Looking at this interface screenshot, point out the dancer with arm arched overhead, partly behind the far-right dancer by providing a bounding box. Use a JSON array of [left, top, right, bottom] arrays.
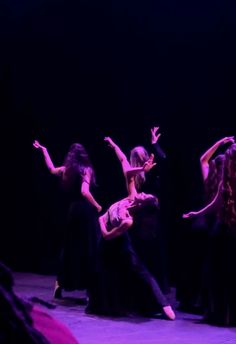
[[177, 136, 234, 313]]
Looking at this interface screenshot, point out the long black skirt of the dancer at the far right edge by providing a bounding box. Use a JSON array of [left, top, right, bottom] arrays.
[[205, 222, 236, 326]]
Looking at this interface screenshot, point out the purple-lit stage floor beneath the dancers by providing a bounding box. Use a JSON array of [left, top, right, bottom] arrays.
[[14, 272, 236, 344]]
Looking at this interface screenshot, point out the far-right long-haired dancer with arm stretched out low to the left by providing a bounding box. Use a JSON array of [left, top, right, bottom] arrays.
[[183, 144, 236, 326]]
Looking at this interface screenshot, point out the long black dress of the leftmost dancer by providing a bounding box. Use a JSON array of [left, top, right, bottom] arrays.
[[58, 174, 100, 291]]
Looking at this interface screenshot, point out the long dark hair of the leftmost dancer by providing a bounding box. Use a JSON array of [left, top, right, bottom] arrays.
[[62, 143, 96, 189]]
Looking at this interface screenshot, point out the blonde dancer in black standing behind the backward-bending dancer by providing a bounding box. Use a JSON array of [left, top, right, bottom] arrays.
[[130, 127, 171, 294]]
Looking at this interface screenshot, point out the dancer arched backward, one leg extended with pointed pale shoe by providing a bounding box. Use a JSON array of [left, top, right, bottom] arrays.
[[86, 138, 175, 320]]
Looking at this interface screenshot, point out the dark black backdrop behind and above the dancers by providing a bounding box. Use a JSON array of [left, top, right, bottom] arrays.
[[0, 0, 236, 290]]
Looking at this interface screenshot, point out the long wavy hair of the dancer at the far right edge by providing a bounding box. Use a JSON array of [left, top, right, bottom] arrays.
[[222, 144, 236, 226]]
